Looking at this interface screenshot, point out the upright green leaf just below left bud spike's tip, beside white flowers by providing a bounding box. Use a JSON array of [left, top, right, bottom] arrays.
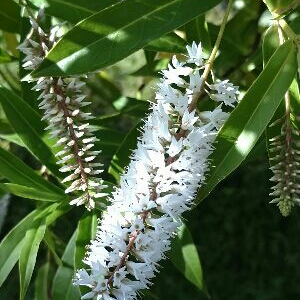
[[75, 212, 97, 269]]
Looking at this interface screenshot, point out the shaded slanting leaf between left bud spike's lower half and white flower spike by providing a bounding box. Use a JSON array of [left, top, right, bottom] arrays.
[[108, 122, 141, 182]]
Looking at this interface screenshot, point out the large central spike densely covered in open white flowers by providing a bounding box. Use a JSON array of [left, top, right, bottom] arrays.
[[74, 43, 237, 300]]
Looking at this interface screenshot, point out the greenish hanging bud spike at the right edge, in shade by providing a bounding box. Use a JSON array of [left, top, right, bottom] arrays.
[[270, 112, 300, 217]]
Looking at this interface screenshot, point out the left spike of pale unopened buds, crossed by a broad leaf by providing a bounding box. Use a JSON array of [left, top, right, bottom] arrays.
[[19, 10, 105, 209]]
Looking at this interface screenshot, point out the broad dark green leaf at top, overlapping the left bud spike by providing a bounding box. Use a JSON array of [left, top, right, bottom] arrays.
[[32, 0, 220, 77]]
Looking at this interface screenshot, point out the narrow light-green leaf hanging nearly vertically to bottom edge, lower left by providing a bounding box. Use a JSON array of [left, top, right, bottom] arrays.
[[19, 219, 46, 300]]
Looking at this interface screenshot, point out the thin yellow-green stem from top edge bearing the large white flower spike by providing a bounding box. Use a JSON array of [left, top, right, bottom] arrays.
[[189, 0, 233, 112]]
